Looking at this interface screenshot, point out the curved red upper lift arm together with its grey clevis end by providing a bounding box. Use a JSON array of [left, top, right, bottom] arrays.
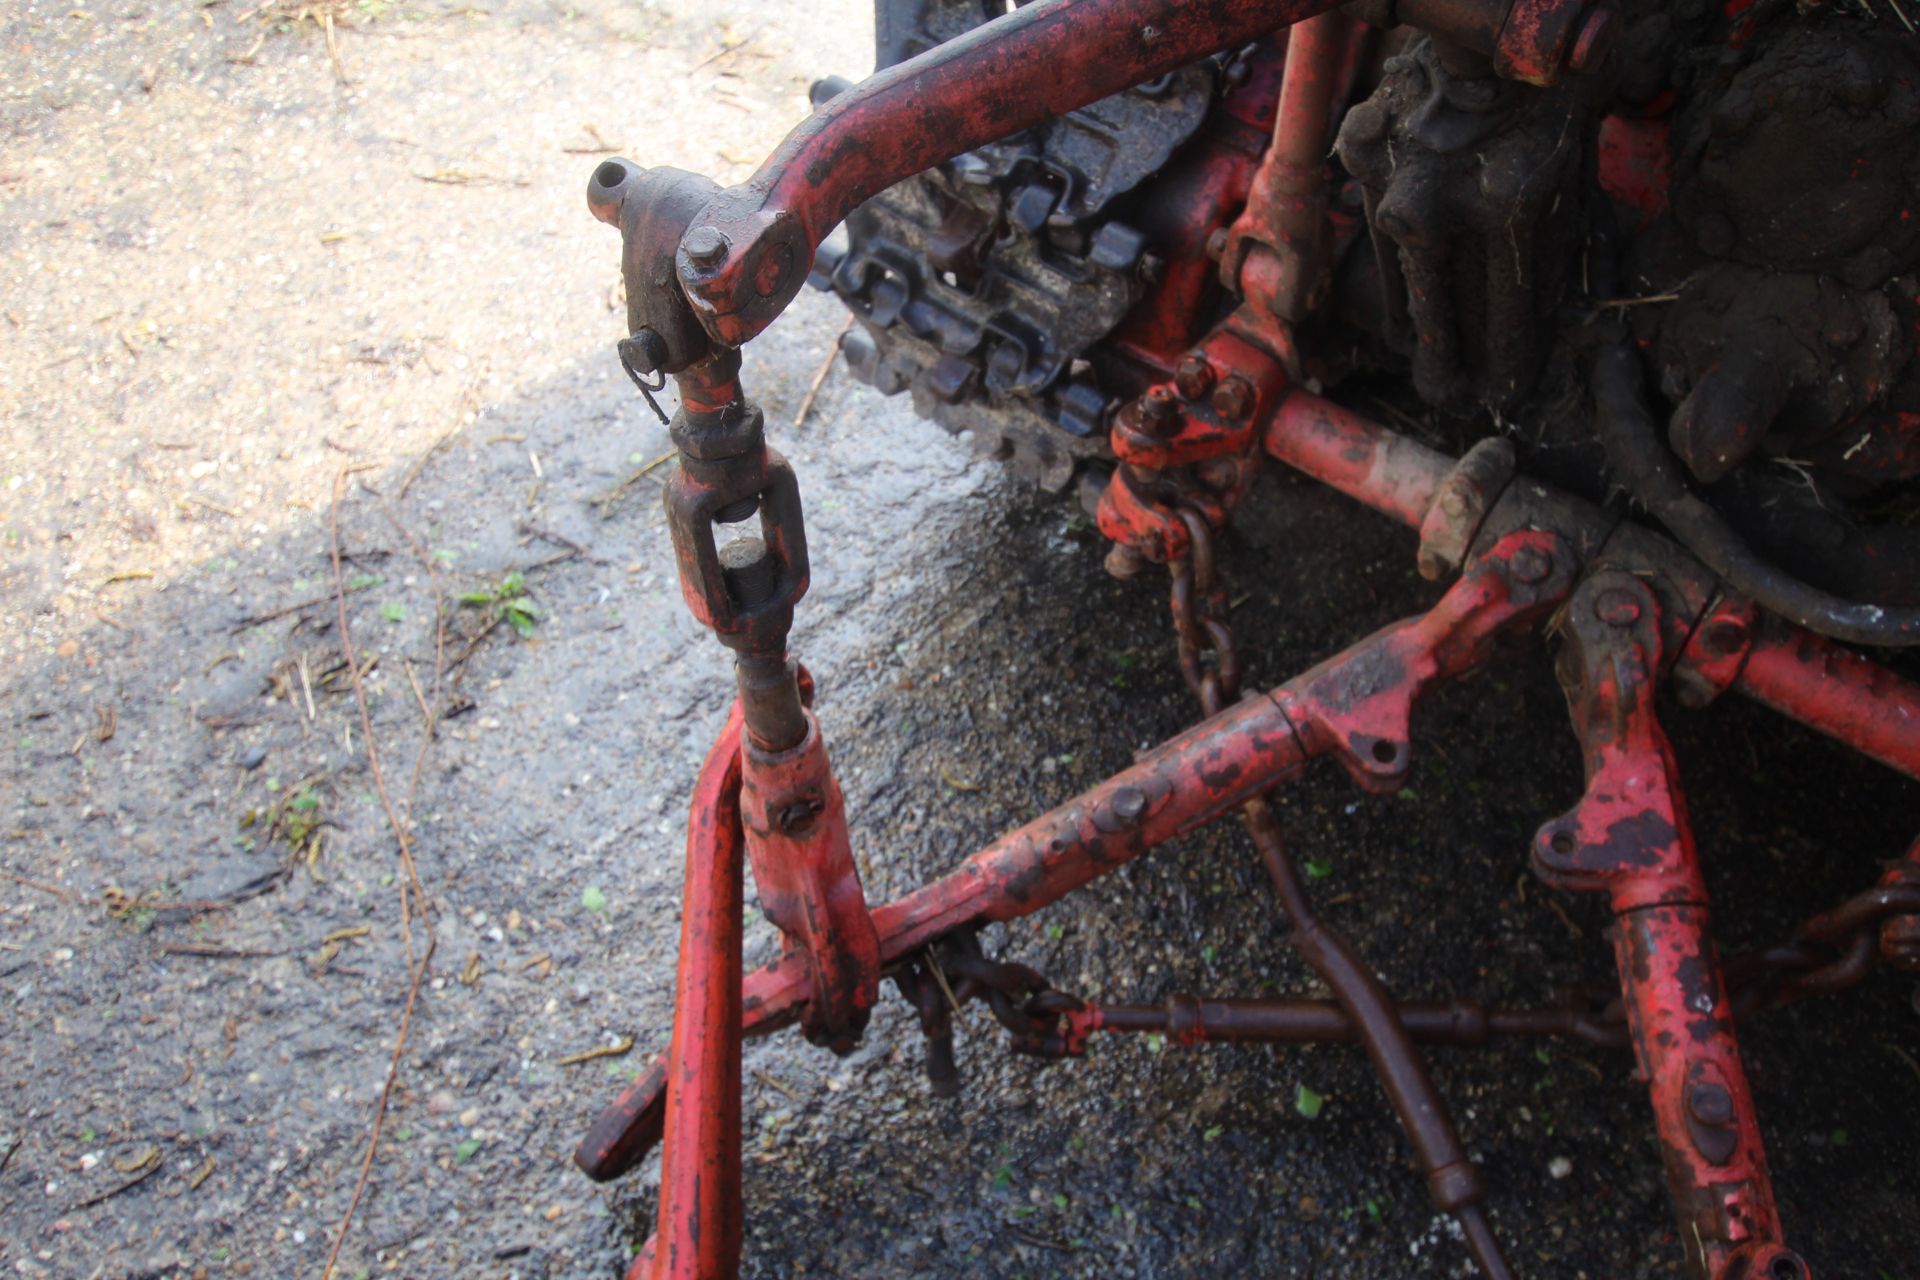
[[588, 0, 1336, 374]]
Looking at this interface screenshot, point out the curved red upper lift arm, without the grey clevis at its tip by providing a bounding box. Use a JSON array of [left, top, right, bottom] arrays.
[[678, 0, 1336, 347]]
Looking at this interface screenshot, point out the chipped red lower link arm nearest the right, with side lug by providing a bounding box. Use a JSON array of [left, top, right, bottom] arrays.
[[1532, 570, 1812, 1280]]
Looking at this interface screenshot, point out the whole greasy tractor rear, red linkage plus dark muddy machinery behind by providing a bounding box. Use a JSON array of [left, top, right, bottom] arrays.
[[576, 0, 1920, 1280]]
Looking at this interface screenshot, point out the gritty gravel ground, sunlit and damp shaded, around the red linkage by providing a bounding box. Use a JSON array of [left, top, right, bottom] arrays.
[[0, 0, 1920, 1280]]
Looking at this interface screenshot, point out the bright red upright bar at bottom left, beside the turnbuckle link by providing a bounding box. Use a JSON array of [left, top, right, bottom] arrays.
[[628, 702, 745, 1280]]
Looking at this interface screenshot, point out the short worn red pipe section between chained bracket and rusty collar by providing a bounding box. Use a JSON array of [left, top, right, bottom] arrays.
[[1265, 391, 1453, 530]]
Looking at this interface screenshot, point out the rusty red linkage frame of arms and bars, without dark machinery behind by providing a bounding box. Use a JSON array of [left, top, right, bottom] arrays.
[[576, 0, 1920, 1280]]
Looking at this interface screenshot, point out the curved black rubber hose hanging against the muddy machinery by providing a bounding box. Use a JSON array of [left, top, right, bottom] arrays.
[[1594, 342, 1920, 645]]
